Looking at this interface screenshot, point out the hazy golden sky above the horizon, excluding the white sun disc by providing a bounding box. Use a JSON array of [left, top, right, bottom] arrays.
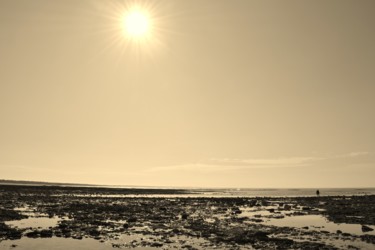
[[0, 0, 375, 188]]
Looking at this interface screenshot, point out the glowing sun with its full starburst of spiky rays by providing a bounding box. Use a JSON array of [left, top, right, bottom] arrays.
[[80, 0, 181, 69]]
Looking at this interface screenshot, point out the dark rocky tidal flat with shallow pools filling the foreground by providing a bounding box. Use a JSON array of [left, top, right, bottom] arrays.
[[0, 185, 375, 250]]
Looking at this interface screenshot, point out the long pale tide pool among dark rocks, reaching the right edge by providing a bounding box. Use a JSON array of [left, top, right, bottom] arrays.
[[262, 215, 375, 235]]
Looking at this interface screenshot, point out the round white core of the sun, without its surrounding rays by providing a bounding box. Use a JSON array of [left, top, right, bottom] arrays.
[[124, 10, 150, 38]]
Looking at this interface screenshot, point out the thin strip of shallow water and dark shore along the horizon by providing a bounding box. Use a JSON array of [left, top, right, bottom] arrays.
[[0, 182, 375, 198]]
